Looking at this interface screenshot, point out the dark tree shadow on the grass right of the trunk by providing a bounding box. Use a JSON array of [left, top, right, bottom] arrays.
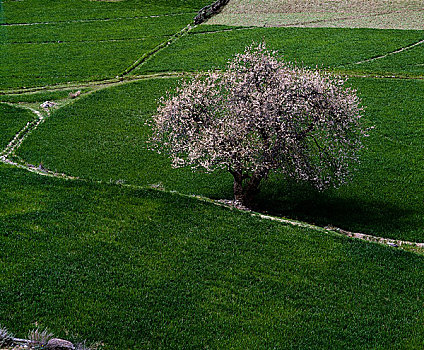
[[252, 175, 418, 241]]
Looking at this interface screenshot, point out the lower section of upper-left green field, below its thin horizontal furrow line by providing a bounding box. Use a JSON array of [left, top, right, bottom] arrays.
[[0, 39, 162, 89]]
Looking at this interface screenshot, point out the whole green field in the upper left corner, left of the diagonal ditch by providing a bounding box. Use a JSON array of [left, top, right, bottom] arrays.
[[0, 1, 212, 90]]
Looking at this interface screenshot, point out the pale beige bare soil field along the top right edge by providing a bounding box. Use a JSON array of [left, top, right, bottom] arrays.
[[208, 0, 424, 30]]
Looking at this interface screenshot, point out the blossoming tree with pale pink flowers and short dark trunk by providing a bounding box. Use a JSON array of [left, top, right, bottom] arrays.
[[152, 44, 365, 206]]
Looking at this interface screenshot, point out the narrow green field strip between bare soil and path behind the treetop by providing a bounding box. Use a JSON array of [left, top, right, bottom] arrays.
[[134, 25, 424, 76]]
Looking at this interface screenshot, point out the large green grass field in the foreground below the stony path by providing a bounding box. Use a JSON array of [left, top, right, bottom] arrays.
[[0, 165, 424, 349]]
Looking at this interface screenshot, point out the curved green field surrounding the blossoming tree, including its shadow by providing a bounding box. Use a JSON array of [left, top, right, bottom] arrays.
[[14, 78, 424, 241]]
